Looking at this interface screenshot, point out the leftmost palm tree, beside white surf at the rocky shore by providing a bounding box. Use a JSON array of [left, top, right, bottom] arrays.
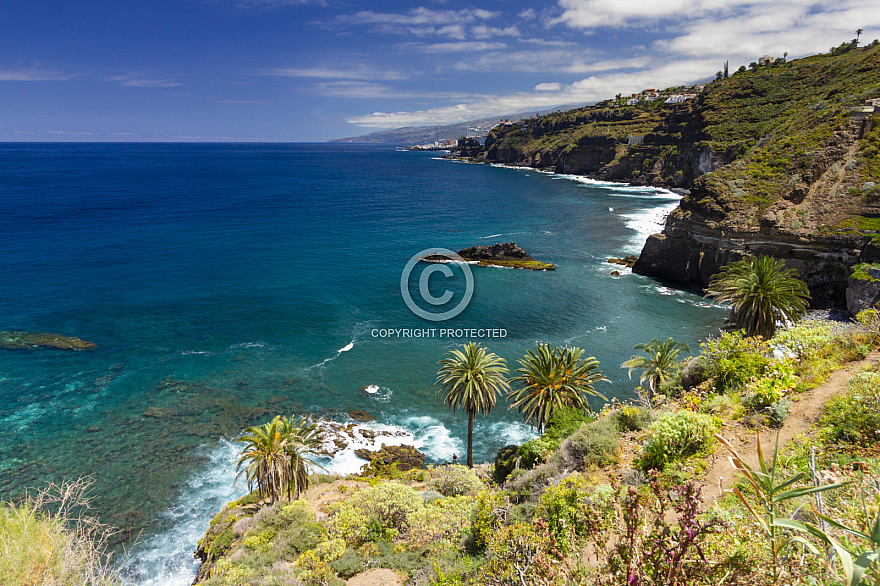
[[235, 416, 290, 502]]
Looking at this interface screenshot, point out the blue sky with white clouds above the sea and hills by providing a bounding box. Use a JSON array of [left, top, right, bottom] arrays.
[[0, 0, 880, 141]]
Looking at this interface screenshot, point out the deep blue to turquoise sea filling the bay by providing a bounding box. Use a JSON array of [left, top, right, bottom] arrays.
[[0, 144, 724, 585]]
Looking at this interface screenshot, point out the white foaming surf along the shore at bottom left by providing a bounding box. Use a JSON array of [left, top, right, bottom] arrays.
[[123, 440, 247, 586]]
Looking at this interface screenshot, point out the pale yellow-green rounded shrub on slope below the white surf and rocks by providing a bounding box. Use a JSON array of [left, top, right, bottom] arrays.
[[329, 481, 425, 544]]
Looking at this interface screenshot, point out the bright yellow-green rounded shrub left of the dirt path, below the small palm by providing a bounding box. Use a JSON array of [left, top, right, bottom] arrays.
[[641, 411, 718, 470]]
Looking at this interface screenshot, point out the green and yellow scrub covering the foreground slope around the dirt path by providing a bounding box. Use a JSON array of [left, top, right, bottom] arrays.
[[175, 312, 880, 586]]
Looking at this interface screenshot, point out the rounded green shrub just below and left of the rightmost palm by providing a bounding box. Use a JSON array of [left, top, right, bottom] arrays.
[[700, 332, 770, 392]]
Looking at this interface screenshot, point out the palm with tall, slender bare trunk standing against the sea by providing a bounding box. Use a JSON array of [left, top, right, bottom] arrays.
[[436, 342, 510, 468]]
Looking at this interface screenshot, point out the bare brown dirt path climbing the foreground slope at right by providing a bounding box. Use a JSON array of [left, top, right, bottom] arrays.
[[703, 351, 880, 506]]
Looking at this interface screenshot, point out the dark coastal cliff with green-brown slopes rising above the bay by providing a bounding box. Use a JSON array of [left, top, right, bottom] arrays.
[[470, 45, 880, 307]]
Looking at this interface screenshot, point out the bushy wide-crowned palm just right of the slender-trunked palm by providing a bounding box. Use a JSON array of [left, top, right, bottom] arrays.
[[506, 342, 610, 432]]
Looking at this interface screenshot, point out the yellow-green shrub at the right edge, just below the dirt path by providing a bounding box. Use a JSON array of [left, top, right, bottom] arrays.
[[820, 372, 880, 448]]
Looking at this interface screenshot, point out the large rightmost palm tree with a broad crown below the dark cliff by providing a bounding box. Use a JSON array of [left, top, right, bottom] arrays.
[[706, 255, 810, 338]]
